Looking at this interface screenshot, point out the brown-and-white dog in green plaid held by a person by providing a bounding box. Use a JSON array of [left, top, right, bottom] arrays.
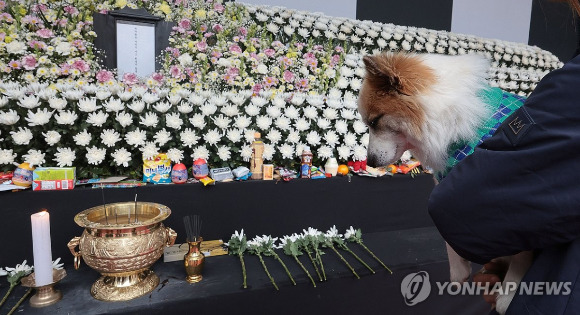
[[359, 53, 532, 314]]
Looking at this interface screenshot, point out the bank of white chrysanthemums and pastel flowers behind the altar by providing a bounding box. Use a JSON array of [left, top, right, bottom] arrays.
[[0, 0, 561, 177]]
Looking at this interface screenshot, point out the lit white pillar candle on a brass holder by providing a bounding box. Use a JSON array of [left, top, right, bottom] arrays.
[[30, 210, 52, 287]]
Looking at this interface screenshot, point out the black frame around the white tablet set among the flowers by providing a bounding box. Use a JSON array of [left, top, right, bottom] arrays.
[[93, 7, 176, 71]]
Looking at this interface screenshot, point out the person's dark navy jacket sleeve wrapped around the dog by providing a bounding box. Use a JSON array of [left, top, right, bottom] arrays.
[[429, 57, 580, 264]]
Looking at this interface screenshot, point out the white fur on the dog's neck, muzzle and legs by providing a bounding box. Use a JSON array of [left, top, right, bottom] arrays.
[[359, 54, 532, 314]]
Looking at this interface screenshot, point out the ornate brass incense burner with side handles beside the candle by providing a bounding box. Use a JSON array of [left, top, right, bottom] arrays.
[[68, 202, 177, 301]]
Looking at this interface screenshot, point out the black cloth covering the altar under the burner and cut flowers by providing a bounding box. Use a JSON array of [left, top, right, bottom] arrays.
[[0, 175, 489, 314]]
